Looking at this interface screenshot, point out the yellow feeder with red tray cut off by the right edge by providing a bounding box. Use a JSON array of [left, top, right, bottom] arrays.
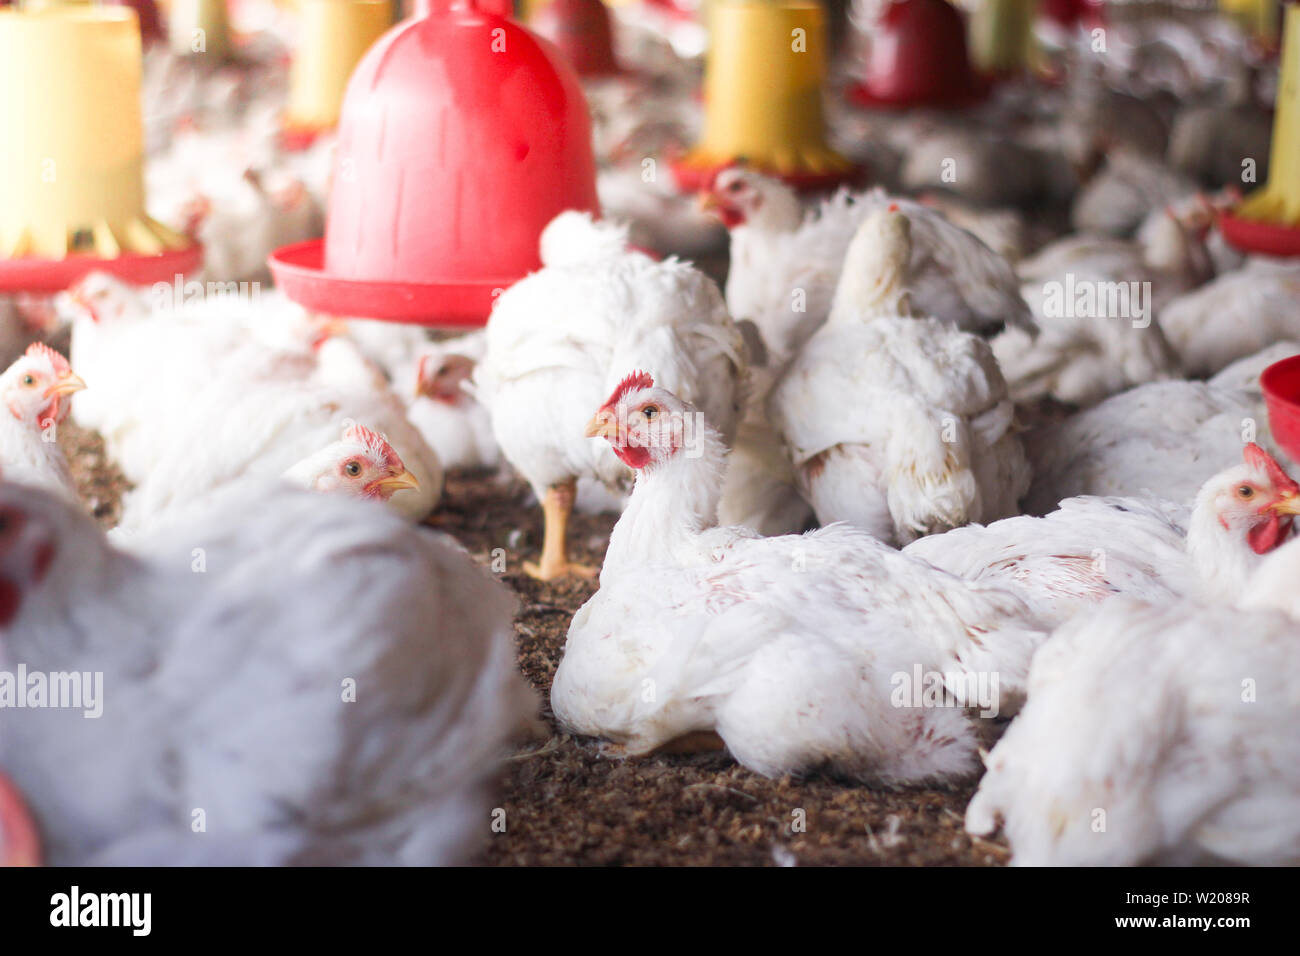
[[1219, 4, 1300, 256]]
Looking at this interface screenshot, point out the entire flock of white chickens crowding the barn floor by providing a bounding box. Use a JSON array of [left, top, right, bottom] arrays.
[[0, 1, 1300, 865]]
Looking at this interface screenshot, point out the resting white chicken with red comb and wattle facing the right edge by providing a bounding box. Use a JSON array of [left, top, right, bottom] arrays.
[[906, 445, 1300, 627]]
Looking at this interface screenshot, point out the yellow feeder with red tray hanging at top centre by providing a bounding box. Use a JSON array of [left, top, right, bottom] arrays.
[[673, 0, 862, 191]]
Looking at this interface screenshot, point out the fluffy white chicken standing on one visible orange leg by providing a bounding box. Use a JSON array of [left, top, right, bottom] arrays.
[[475, 212, 744, 580]]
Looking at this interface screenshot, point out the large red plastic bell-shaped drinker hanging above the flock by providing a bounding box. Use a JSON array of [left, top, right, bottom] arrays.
[[270, 0, 599, 325]]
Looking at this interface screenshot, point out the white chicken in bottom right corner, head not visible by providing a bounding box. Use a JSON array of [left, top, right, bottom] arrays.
[[966, 598, 1300, 866]]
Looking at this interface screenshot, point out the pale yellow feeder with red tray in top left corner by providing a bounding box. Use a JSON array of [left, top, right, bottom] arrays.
[[0, 7, 203, 293]]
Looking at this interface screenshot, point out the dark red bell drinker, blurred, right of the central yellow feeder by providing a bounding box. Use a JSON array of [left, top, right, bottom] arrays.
[[849, 0, 989, 109]]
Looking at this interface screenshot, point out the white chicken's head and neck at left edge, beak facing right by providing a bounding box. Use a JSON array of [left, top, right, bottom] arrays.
[[0, 342, 86, 501]]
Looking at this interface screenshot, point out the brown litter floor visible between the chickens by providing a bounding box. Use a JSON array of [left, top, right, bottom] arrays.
[[59, 423, 1008, 866]]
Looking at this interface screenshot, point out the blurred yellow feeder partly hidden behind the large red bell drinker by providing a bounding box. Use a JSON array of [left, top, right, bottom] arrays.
[[285, 0, 395, 148]]
